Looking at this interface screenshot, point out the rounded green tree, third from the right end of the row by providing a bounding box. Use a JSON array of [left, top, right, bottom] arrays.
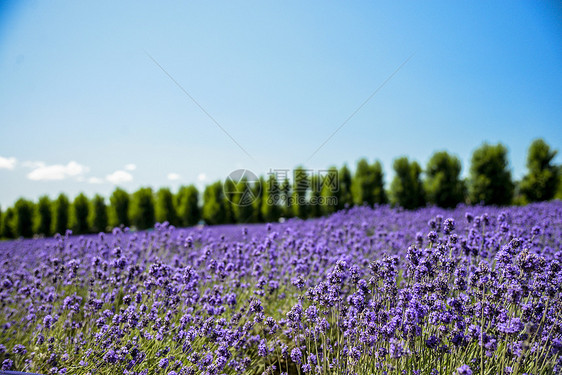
[[424, 151, 464, 208]]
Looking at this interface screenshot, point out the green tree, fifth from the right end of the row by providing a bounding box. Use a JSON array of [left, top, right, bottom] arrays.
[[351, 159, 387, 206]]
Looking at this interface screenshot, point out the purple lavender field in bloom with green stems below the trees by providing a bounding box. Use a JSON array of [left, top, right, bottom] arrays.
[[0, 201, 562, 375]]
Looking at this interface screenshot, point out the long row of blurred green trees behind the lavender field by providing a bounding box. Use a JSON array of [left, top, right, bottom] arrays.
[[0, 139, 562, 238]]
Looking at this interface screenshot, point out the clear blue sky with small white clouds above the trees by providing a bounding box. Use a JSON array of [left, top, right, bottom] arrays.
[[0, 1, 562, 208]]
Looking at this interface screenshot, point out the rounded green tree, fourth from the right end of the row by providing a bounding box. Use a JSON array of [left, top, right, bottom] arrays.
[[390, 157, 425, 210]]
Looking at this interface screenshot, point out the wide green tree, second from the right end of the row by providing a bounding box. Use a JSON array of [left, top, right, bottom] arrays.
[[469, 143, 514, 206]]
